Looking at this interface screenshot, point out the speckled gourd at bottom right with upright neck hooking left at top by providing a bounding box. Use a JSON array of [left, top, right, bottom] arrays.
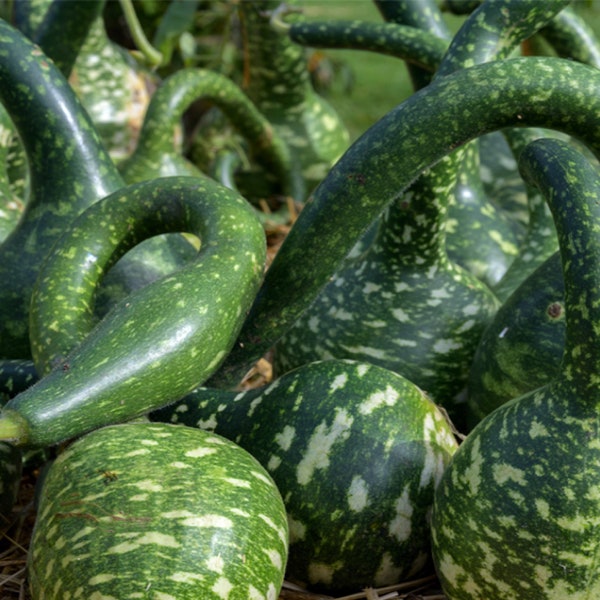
[[432, 135, 600, 600]]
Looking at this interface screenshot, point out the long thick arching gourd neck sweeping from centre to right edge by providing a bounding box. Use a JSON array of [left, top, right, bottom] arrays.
[[211, 57, 600, 386]]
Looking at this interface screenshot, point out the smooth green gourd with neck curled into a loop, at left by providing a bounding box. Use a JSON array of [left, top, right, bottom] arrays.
[[0, 177, 265, 447]]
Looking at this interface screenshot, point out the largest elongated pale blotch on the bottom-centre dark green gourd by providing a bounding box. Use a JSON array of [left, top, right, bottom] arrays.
[[296, 408, 354, 485]]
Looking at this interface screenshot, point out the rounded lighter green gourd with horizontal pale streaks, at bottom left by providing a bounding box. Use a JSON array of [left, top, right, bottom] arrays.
[[27, 423, 288, 600]]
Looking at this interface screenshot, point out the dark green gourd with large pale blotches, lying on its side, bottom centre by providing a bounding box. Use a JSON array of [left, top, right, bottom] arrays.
[[151, 360, 457, 595]]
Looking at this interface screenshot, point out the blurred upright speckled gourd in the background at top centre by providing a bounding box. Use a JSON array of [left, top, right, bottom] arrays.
[[238, 0, 349, 192]]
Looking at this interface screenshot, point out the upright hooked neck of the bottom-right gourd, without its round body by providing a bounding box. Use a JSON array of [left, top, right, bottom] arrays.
[[519, 139, 600, 402]]
